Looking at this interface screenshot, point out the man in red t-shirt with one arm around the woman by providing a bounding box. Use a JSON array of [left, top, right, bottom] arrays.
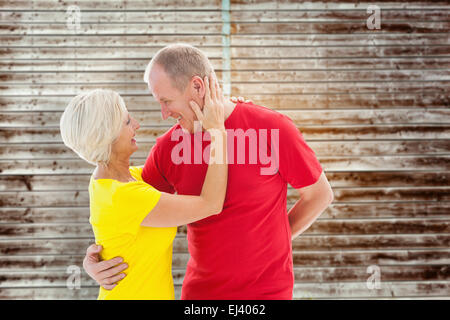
[[84, 45, 333, 300]]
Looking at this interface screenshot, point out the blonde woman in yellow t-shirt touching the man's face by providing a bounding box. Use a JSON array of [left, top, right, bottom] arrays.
[[60, 76, 228, 300]]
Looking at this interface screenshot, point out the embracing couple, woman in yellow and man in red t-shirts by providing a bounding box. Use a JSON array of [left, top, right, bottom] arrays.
[[61, 44, 333, 300]]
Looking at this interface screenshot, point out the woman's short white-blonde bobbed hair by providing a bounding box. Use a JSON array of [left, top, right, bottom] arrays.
[[59, 89, 127, 165]]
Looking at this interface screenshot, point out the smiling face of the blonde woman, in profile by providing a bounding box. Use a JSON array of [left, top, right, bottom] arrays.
[[111, 111, 140, 157]]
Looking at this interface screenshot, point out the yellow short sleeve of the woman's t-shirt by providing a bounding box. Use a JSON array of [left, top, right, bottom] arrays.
[[113, 182, 161, 235]]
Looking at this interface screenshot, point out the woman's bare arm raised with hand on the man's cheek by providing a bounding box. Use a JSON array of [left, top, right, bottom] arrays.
[[141, 75, 228, 227]]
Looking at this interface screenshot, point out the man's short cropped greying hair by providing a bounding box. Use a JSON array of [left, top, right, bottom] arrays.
[[144, 43, 214, 92]]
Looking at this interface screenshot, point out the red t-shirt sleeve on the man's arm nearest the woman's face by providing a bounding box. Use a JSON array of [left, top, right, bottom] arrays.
[[142, 143, 175, 193]]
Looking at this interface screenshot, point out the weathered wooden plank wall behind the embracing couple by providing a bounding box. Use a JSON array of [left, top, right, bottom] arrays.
[[0, 0, 450, 299]]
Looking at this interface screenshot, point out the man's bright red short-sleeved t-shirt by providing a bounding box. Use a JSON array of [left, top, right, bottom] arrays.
[[142, 103, 322, 300]]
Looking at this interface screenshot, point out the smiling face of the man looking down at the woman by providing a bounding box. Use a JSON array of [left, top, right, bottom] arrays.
[[148, 64, 204, 133]]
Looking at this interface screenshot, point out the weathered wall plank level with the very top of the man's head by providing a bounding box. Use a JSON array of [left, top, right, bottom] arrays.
[[0, 34, 450, 48]]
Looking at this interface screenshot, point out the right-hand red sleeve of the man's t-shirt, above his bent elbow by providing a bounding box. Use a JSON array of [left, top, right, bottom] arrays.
[[278, 115, 322, 189]]
